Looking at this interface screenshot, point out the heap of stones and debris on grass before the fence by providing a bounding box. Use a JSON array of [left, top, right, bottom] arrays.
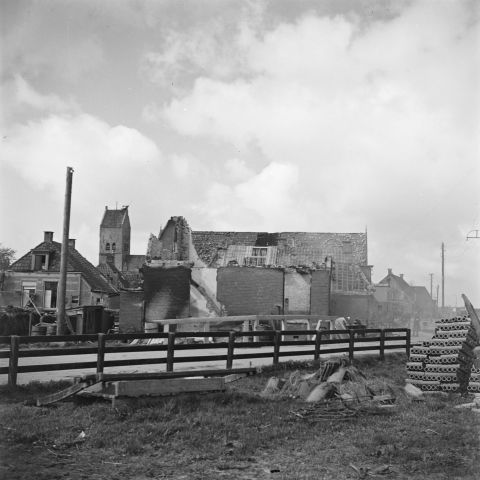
[[261, 359, 396, 421]]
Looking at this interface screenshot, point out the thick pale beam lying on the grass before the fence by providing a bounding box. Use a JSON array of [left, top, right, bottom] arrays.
[[114, 377, 225, 397]]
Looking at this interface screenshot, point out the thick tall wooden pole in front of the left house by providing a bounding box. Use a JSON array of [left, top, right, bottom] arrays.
[[57, 167, 73, 335]]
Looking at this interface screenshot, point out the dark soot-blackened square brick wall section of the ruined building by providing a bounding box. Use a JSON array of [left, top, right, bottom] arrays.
[[142, 266, 191, 322]]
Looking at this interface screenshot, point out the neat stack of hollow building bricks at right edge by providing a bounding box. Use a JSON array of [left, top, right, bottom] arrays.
[[407, 316, 480, 392]]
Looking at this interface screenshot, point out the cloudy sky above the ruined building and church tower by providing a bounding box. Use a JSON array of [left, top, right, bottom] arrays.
[[0, 0, 480, 306]]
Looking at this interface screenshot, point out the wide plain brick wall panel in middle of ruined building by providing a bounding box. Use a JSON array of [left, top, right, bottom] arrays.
[[217, 267, 284, 315]]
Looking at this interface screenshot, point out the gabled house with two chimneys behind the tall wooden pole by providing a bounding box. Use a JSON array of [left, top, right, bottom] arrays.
[[0, 232, 118, 312]]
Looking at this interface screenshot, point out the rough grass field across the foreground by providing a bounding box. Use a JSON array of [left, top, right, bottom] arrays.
[[0, 355, 480, 480]]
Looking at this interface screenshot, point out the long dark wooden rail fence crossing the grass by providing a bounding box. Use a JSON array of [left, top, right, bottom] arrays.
[[0, 328, 411, 385]]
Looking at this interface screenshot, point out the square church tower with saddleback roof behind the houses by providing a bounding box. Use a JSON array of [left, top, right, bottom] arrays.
[[98, 206, 130, 271]]
